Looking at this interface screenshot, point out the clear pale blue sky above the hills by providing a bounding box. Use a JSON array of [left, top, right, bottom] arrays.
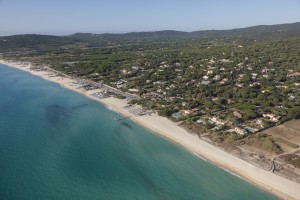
[[0, 0, 300, 35]]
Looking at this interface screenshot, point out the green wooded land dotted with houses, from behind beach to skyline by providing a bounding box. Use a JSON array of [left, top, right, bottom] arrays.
[[0, 23, 300, 142]]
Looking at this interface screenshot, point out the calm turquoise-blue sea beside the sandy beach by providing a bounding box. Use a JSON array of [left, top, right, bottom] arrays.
[[0, 65, 276, 200]]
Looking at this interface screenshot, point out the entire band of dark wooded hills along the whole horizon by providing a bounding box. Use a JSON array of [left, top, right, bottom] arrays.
[[0, 22, 300, 52]]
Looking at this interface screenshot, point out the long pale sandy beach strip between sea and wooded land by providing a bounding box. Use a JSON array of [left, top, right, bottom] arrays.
[[0, 60, 300, 199]]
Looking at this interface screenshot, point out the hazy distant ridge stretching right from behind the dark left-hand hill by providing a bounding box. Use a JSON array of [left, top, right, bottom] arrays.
[[69, 22, 300, 40]]
